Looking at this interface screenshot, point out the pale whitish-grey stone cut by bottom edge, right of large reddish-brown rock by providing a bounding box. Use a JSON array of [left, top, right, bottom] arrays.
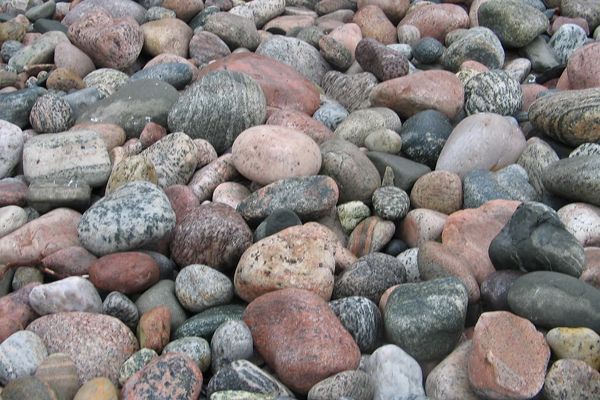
[[365, 344, 425, 400]]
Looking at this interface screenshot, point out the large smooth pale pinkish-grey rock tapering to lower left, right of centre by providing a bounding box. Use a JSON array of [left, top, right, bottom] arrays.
[[436, 113, 525, 177]]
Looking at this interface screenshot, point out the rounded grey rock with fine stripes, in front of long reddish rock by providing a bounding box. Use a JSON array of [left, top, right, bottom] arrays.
[[168, 71, 266, 153]]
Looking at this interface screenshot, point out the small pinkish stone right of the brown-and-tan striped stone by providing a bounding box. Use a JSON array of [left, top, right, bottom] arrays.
[[399, 208, 448, 247]]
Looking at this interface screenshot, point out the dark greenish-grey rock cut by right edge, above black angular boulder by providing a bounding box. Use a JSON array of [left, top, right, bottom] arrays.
[[542, 155, 600, 206]]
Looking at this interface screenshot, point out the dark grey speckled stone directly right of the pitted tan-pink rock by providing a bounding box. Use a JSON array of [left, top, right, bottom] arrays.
[[331, 253, 406, 304]]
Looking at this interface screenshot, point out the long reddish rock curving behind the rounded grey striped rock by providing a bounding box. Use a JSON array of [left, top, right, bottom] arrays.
[[200, 52, 320, 115]]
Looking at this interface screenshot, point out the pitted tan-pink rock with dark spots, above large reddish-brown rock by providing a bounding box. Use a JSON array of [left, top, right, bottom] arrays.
[[234, 225, 335, 302]]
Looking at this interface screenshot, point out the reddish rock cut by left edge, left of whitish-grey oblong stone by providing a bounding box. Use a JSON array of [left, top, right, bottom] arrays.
[[0, 282, 39, 343]]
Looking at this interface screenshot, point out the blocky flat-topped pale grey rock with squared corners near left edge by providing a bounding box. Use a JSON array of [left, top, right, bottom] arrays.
[[23, 130, 111, 186]]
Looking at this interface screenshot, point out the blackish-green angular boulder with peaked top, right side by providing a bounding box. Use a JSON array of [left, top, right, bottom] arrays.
[[489, 202, 585, 278]]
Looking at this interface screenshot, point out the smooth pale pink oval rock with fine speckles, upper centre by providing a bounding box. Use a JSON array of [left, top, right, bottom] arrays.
[[231, 125, 321, 185]]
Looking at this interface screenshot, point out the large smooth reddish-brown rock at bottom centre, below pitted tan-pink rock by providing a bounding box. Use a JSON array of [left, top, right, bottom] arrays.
[[243, 289, 360, 394]]
